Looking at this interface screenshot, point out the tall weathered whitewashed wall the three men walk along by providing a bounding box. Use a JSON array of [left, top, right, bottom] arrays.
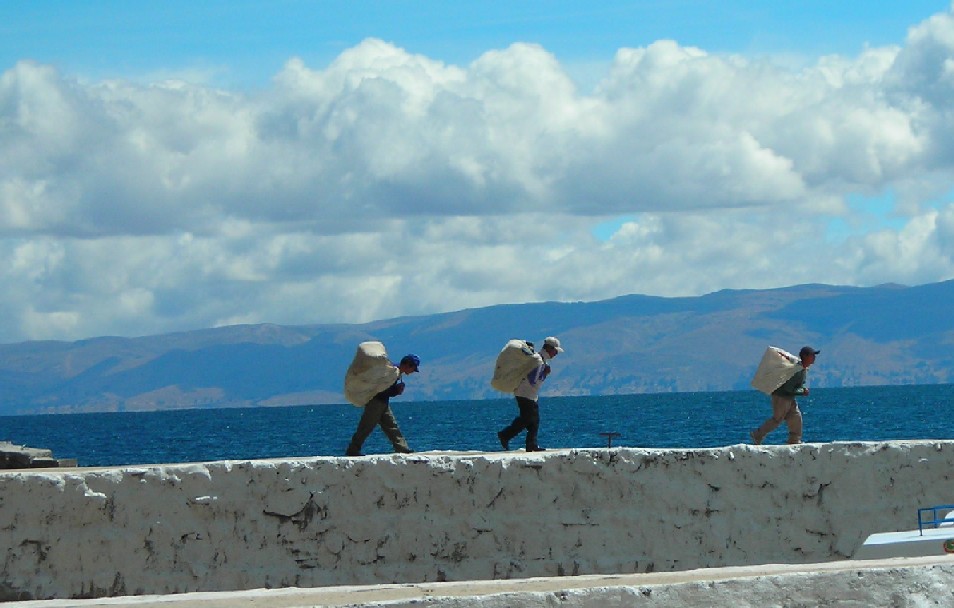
[[0, 441, 954, 599]]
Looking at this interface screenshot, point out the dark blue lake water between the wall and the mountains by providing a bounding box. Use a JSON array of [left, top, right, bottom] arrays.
[[0, 385, 954, 466]]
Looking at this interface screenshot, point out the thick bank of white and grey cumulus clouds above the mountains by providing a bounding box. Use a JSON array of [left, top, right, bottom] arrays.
[[0, 13, 954, 341]]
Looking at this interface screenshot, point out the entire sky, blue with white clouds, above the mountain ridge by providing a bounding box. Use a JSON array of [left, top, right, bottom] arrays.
[[0, 0, 954, 342]]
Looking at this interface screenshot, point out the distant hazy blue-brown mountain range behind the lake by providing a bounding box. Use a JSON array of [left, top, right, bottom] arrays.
[[0, 281, 954, 415]]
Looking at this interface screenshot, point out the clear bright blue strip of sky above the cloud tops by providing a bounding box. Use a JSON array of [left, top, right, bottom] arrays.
[[0, 0, 949, 86]]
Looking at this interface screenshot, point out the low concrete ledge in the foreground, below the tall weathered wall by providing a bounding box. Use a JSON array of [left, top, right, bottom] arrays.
[[10, 557, 954, 608]]
